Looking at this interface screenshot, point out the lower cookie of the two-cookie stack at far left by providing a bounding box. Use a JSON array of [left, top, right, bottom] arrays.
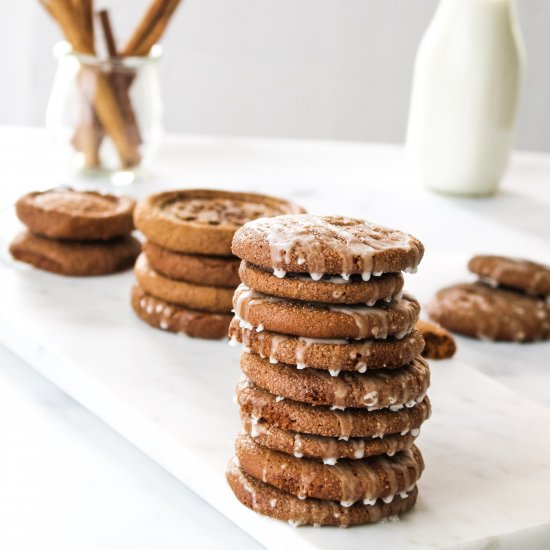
[[10, 231, 141, 276]]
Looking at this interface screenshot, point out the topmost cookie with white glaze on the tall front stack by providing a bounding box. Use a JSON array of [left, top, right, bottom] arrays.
[[233, 214, 424, 280]]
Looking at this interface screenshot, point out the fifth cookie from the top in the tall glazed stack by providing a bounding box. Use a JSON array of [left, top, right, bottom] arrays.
[[241, 351, 430, 411]]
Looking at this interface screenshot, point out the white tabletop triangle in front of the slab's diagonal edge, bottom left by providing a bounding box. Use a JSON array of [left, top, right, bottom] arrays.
[[0, 346, 260, 550]]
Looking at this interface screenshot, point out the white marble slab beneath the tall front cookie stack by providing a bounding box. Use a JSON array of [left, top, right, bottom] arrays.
[[0, 266, 550, 549]]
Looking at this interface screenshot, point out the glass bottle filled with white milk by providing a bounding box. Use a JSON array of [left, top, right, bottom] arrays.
[[407, 0, 524, 195]]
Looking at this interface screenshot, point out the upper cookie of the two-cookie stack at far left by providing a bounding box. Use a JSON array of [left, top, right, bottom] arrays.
[[15, 188, 135, 241]]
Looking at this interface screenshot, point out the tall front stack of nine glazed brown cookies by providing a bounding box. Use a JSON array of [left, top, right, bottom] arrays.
[[227, 215, 430, 526]]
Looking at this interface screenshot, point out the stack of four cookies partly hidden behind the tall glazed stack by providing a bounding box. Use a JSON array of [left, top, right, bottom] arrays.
[[132, 189, 303, 338]]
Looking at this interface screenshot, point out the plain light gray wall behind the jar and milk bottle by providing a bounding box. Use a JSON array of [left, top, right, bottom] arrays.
[[0, 0, 550, 150]]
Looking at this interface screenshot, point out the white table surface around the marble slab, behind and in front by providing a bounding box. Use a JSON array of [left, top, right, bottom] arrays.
[[0, 129, 550, 548]]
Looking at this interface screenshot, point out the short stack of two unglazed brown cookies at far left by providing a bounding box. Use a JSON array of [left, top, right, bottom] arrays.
[[10, 188, 141, 276]]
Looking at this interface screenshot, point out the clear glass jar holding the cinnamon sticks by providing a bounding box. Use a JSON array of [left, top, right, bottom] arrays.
[[46, 42, 162, 184]]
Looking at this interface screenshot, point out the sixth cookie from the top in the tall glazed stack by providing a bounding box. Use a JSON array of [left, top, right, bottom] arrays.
[[237, 380, 430, 440]]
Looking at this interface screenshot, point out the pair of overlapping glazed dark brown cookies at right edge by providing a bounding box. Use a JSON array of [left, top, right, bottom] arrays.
[[427, 256, 550, 342]]
